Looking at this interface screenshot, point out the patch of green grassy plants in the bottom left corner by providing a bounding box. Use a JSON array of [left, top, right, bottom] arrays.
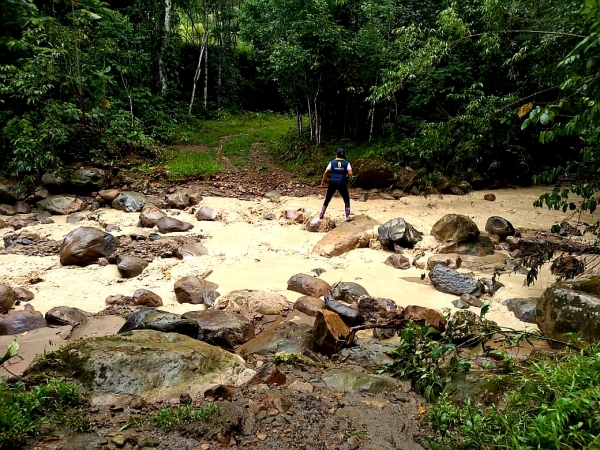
[[0, 379, 87, 448]]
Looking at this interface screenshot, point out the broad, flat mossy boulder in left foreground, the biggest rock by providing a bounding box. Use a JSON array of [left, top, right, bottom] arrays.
[[46, 330, 254, 404]]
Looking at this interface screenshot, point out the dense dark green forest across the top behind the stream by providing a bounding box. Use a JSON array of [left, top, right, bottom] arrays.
[[0, 0, 600, 190]]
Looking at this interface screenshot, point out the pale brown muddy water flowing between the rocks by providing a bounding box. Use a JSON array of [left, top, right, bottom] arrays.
[[0, 187, 595, 329]]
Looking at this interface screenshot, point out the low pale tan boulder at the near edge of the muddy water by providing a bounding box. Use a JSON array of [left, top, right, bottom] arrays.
[[215, 289, 291, 318]]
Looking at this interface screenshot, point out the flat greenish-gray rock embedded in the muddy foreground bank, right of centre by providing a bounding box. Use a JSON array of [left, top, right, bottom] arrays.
[[323, 369, 397, 394]]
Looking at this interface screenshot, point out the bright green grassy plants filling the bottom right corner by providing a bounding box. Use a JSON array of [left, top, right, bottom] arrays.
[[426, 345, 600, 449]]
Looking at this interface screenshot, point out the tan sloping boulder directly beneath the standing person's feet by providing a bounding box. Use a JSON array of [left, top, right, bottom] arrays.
[[312, 216, 379, 258]]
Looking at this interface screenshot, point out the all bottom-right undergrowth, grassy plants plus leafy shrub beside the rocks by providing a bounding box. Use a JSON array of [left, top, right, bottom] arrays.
[[387, 305, 600, 450]]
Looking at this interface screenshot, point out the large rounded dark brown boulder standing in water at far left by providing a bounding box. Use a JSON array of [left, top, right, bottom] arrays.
[[59, 227, 117, 266]]
